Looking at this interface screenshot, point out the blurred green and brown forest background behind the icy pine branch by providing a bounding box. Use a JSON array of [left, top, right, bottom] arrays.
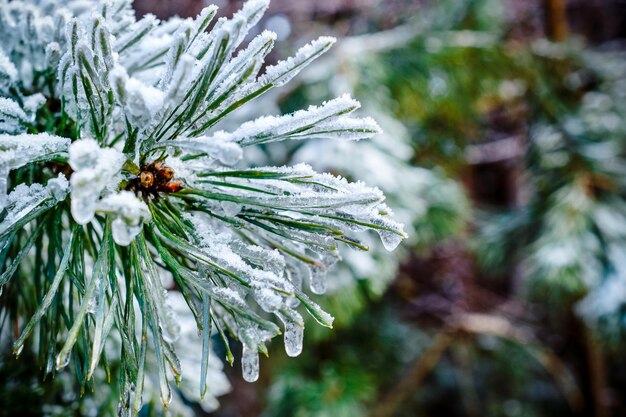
[[0, 0, 626, 417]]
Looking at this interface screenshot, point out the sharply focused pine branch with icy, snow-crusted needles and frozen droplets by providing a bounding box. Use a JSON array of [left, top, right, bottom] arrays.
[[0, 0, 405, 415]]
